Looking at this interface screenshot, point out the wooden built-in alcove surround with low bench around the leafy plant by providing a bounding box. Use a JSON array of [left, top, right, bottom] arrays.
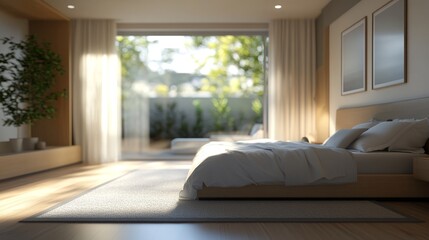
[[0, 0, 82, 180]]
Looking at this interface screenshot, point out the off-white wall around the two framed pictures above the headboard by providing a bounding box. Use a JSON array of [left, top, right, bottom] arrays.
[[329, 0, 429, 134]]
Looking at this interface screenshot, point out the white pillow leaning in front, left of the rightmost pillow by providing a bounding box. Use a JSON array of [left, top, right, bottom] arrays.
[[350, 122, 412, 152]]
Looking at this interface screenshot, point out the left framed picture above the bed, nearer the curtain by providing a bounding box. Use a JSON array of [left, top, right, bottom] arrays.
[[341, 17, 366, 95]]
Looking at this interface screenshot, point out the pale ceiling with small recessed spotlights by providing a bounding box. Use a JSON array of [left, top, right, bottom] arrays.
[[43, 0, 330, 23]]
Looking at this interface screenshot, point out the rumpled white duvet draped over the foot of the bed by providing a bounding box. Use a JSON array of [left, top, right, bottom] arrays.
[[180, 140, 357, 200]]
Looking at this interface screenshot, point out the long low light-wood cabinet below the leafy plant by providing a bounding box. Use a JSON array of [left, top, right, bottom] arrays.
[[0, 146, 81, 180]]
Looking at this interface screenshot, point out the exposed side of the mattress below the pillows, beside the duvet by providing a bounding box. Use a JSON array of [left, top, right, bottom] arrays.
[[352, 152, 428, 174]]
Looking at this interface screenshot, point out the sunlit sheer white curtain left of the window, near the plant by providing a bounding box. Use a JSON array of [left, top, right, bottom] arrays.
[[72, 20, 120, 164]]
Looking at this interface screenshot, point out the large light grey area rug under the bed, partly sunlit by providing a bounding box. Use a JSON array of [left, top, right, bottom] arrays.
[[23, 169, 415, 223]]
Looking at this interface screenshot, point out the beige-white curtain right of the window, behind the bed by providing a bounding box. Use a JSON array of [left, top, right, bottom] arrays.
[[268, 19, 316, 140]]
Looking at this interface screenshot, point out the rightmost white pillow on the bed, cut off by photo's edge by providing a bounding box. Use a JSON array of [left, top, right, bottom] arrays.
[[389, 119, 429, 153]]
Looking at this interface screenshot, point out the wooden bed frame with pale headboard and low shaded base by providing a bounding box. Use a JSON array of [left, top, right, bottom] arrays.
[[198, 97, 429, 199]]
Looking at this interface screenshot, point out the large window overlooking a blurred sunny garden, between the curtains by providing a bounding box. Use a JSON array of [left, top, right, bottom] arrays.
[[117, 35, 266, 158]]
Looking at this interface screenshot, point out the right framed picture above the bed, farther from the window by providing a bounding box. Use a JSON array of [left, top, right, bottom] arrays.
[[372, 0, 407, 89]]
